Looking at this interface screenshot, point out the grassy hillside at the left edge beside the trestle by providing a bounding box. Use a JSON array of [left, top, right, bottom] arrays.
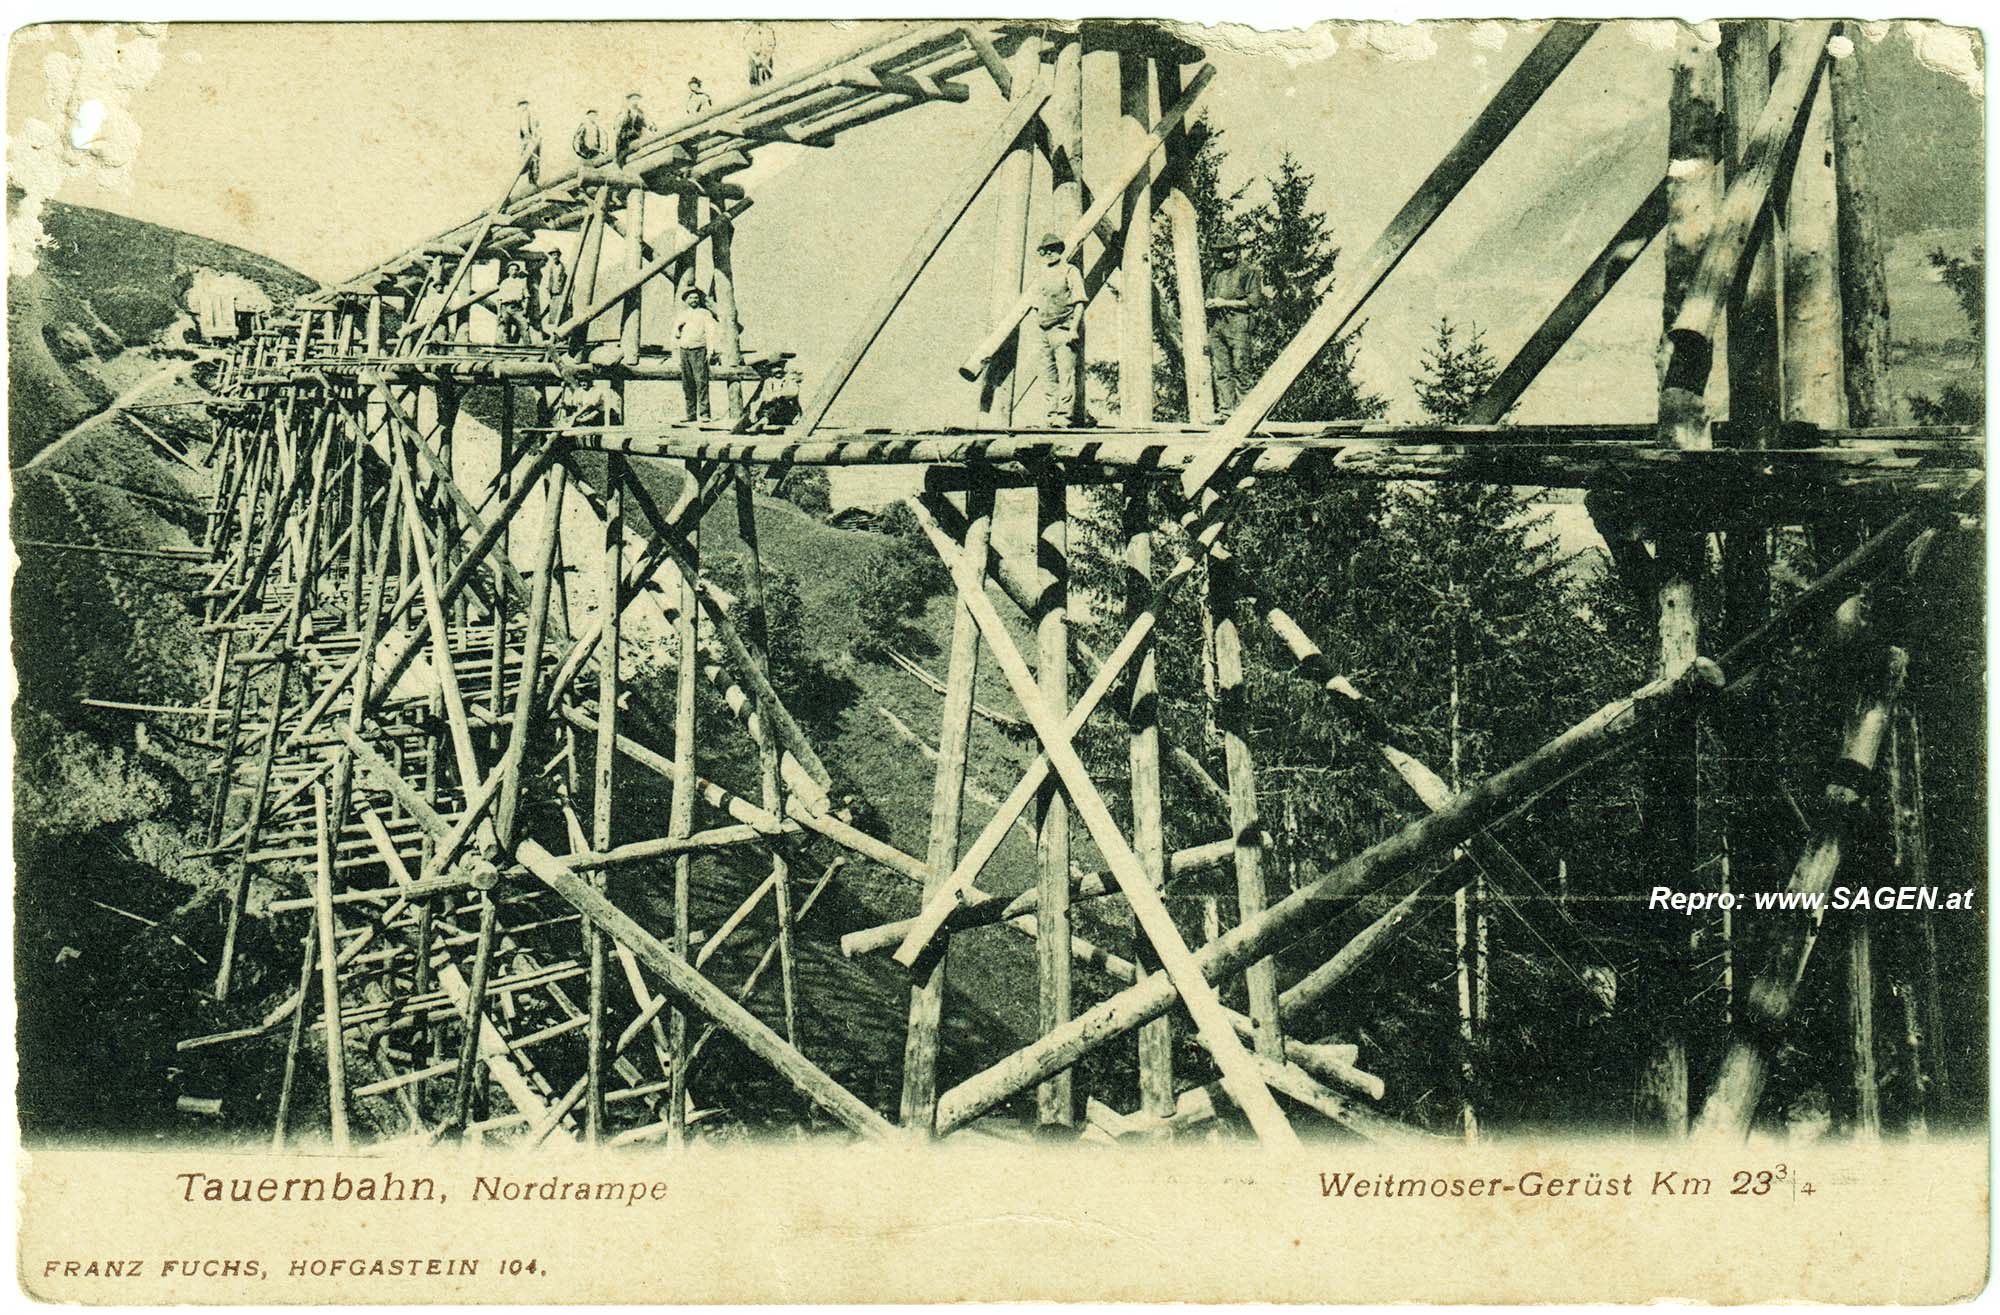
[[8, 196, 308, 1135]]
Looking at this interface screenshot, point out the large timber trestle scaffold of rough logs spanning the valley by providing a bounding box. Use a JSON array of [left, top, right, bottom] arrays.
[[182, 22, 1982, 1147]]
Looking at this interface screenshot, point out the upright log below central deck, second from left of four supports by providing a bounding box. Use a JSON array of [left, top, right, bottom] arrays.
[[1034, 470, 1076, 1129]]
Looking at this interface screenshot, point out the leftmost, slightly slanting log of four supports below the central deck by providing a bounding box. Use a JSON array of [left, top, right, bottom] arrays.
[[902, 480, 994, 1135]]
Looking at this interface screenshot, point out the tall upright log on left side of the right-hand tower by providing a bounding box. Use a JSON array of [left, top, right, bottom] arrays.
[[1640, 28, 1722, 1135]]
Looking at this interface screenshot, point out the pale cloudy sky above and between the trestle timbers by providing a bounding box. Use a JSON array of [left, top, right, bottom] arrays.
[[8, 22, 1984, 451]]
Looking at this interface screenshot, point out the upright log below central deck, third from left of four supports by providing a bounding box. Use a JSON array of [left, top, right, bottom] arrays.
[[1124, 482, 1176, 1119]]
